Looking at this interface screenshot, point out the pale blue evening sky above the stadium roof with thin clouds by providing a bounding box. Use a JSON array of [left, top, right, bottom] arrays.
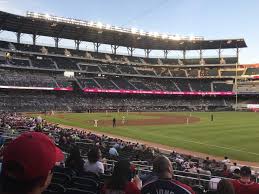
[[0, 0, 259, 63]]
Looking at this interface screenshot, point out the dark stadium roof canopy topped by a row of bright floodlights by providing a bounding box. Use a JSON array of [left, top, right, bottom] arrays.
[[0, 11, 247, 50]]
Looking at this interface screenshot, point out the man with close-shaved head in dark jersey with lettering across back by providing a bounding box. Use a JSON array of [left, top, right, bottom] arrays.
[[141, 156, 195, 194]]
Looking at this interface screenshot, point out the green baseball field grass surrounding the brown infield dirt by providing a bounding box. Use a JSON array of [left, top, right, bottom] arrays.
[[37, 112, 259, 162]]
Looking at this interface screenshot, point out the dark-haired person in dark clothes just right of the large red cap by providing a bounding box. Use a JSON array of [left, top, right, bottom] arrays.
[[65, 146, 85, 173]]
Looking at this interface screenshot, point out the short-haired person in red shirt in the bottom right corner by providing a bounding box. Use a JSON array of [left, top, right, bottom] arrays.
[[232, 166, 259, 194]]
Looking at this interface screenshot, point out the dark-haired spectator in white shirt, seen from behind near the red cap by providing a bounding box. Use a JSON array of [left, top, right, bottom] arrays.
[[84, 147, 104, 174]]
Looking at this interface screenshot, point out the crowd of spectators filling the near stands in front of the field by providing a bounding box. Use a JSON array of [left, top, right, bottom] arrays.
[[0, 113, 259, 194]]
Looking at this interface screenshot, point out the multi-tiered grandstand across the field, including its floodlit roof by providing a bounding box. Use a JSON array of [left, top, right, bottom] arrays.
[[0, 12, 259, 111]]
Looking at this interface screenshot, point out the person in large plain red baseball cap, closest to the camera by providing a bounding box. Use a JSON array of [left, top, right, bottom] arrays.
[[0, 132, 64, 194]]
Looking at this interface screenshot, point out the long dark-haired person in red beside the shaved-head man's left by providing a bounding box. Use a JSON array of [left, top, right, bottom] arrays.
[[102, 160, 141, 194]]
